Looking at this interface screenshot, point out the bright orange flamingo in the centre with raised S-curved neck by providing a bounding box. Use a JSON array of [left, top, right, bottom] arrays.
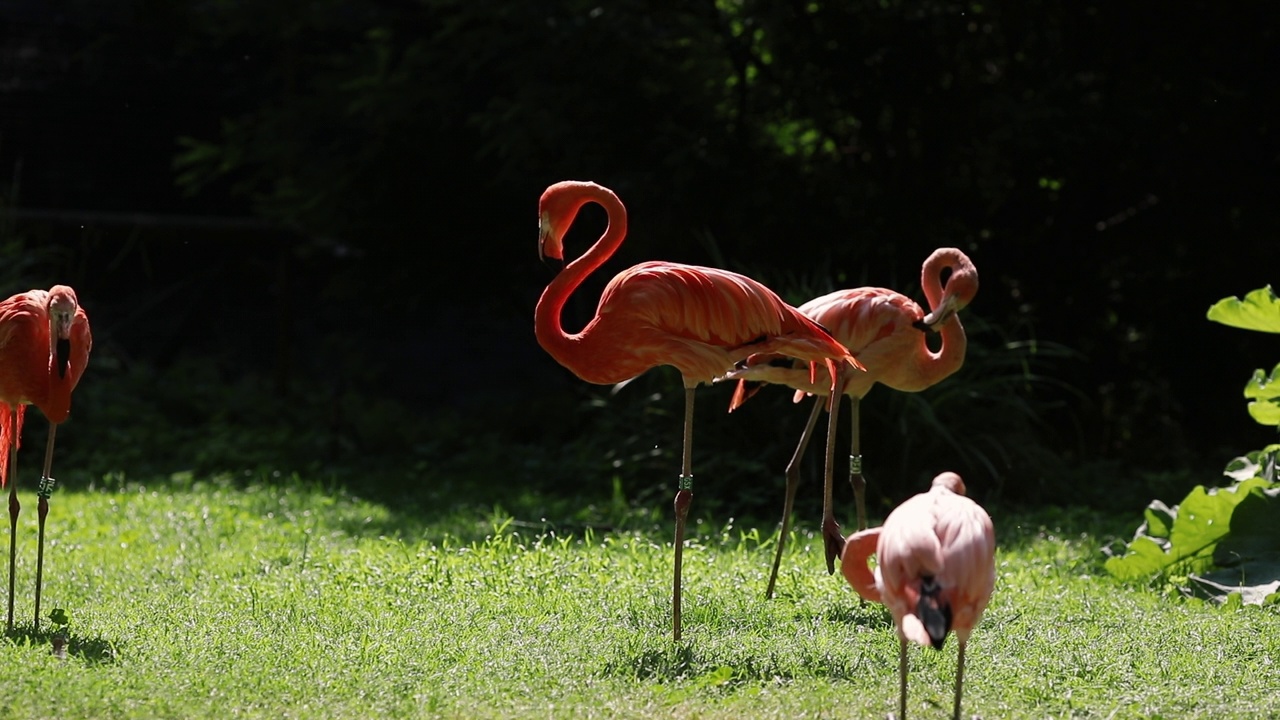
[[534, 181, 861, 642]]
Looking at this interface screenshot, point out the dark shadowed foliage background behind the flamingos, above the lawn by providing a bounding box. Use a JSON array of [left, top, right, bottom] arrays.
[[0, 0, 1280, 516]]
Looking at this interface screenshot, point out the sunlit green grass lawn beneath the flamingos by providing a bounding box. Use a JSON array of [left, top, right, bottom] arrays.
[[0, 479, 1280, 719]]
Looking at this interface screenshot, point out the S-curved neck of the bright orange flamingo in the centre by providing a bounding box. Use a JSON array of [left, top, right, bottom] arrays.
[[534, 184, 627, 360]]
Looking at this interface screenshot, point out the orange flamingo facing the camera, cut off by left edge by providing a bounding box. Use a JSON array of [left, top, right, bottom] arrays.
[[0, 284, 93, 633]]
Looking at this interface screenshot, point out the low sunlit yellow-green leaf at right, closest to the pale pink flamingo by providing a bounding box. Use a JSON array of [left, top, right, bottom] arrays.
[[1106, 478, 1271, 580]]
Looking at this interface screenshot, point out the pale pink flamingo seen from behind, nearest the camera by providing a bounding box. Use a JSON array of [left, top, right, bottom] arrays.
[[841, 473, 996, 720]]
